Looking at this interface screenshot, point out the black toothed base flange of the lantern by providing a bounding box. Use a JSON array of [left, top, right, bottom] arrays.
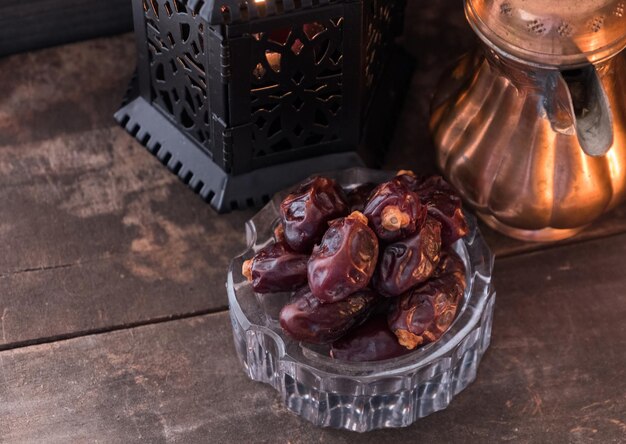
[[114, 47, 414, 213]]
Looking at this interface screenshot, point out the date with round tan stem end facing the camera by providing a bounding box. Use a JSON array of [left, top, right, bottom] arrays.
[[363, 179, 426, 242]]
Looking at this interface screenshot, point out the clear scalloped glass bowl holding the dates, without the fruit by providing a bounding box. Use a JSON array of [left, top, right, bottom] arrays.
[[226, 168, 495, 432]]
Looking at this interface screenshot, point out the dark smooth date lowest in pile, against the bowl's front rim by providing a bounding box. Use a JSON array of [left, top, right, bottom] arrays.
[[330, 315, 409, 362]]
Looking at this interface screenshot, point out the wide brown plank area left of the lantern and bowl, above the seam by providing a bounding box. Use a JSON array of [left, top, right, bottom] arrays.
[[0, 36, 252, 349]]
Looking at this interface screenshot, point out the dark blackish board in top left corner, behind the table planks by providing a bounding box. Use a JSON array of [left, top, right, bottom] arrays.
[[0, 0, 133, 56]]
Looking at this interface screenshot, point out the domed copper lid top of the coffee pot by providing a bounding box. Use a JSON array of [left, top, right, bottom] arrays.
[[465, 0, 626, 67]]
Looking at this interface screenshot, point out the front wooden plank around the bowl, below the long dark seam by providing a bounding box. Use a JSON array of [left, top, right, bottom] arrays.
[[0, 235, 626, 443]]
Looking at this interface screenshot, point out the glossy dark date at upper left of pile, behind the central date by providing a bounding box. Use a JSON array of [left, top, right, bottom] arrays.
[[280, 177, 349, 253]]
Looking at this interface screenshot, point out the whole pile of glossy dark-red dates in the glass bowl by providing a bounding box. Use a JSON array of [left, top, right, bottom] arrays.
[[242, 171, 468, 361]]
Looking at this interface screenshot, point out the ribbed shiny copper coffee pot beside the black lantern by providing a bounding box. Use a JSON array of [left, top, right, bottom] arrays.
[[430, 0, 626, 241]]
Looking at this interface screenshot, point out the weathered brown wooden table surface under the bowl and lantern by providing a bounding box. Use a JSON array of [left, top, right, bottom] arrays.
[[0, 1, 626, 444]]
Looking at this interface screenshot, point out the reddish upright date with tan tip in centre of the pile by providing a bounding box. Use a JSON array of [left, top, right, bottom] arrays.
[[308, 211, 378, 303]]
